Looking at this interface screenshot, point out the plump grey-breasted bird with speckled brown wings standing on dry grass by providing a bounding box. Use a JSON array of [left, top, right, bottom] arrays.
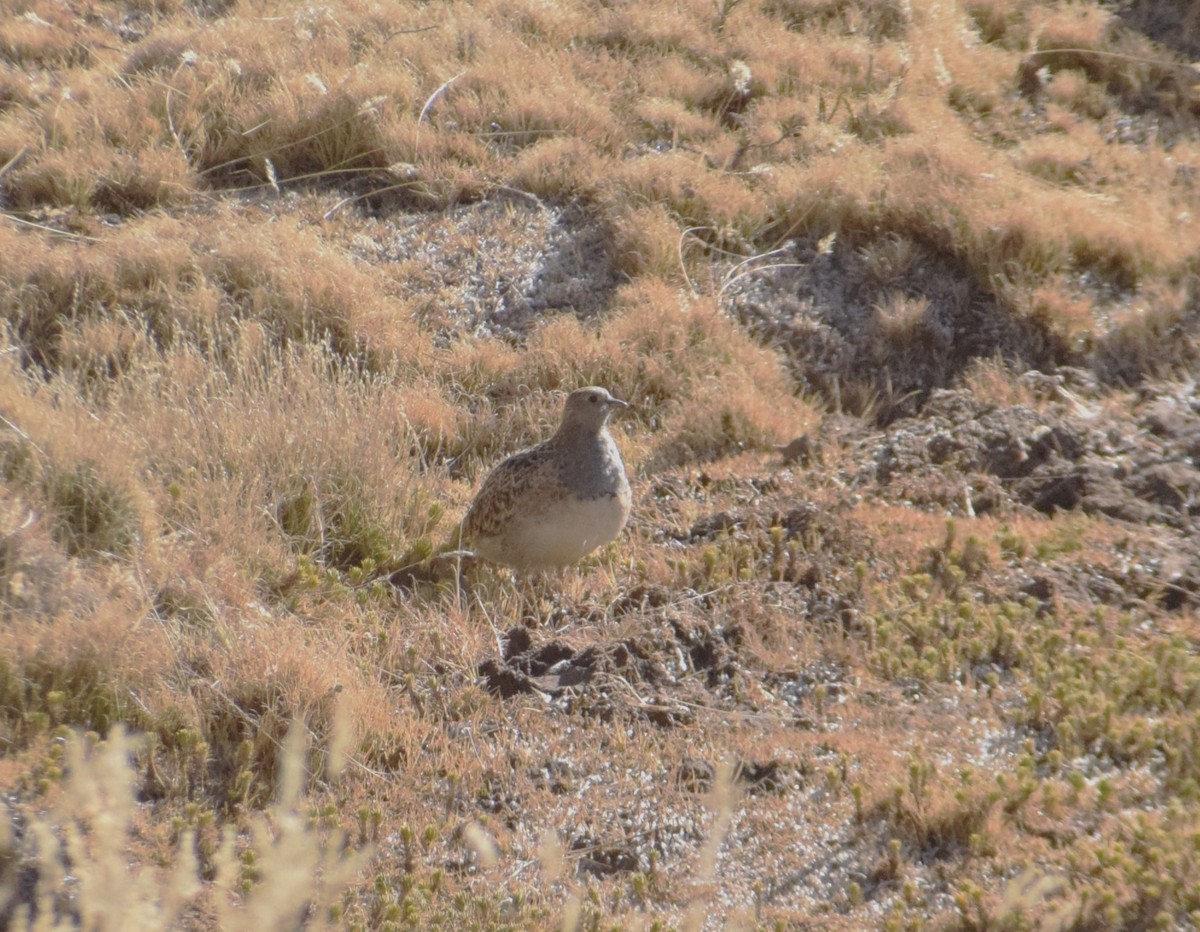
[[460, 385, 632, 573]]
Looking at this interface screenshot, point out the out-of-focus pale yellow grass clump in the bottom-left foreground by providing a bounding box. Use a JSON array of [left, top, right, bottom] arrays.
[[0, 726, 366, 932]]
